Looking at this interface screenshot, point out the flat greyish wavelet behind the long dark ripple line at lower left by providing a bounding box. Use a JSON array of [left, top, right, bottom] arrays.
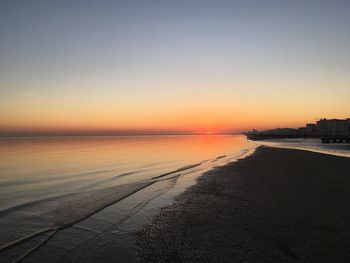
[[0, 181, 154, 252]]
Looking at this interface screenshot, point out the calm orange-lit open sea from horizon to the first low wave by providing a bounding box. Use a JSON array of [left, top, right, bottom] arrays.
[[0, 135, 251, 210]]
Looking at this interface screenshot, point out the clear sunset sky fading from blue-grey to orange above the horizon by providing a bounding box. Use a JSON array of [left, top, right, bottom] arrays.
[[0, 0, 350, 134]]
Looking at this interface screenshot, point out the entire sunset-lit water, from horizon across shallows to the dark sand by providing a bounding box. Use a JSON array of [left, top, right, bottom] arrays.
[[0, 135, 256, 262]]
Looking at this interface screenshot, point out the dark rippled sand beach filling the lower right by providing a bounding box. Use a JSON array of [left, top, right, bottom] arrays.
[[137, 147, 350, 263]]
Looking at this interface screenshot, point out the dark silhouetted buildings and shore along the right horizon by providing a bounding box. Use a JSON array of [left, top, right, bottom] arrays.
[[245, 118, 350, 143]]
